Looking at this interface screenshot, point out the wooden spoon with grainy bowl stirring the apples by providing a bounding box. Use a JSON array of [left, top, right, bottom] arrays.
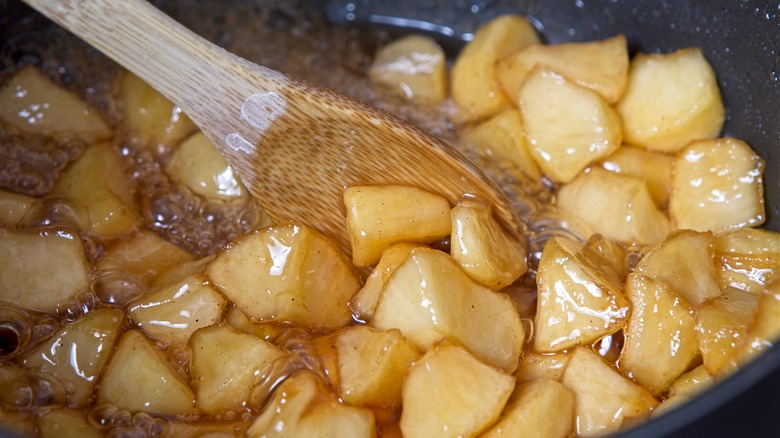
[[24, 0, 519, 252]]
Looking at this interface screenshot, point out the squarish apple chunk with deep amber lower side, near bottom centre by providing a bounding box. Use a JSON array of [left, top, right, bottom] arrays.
[[335, 326, 420, 409]]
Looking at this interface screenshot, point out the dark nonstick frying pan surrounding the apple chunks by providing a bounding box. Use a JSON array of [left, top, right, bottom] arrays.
[[0, 0, 780, 437]]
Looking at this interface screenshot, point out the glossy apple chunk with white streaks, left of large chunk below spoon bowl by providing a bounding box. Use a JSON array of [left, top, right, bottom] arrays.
[[127, 274, 226, 346]]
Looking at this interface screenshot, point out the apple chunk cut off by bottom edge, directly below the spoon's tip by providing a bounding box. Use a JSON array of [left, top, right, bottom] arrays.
[[481, 379, 574, 438]]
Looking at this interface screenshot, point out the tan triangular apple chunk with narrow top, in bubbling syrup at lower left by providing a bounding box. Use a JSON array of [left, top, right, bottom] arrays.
[[97, 330, 195, 415]]
